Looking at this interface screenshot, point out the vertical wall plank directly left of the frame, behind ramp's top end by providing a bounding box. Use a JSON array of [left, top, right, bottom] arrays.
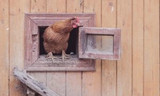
[[9, 0, 30, 96]]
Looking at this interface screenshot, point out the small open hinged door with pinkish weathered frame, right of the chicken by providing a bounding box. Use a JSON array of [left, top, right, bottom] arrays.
[[78, 27, 121, 60]]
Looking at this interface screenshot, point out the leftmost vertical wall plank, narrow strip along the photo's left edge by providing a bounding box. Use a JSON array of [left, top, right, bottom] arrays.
[[0, 0, 9, 96]]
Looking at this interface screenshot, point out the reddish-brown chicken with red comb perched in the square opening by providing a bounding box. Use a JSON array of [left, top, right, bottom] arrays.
[[43, 17, 80, 61]]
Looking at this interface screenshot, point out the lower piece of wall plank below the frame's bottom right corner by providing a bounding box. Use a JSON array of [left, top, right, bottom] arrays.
[[82, 60, 101, 96]]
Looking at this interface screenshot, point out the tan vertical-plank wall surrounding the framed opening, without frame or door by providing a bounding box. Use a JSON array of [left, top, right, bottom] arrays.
[[0, 0, 160, 96]]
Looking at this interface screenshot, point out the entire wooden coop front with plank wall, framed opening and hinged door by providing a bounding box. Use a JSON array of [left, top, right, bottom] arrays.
[[0, 0, 160, 96]]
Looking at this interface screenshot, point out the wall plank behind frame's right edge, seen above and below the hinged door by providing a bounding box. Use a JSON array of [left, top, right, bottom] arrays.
[[82, 0, 102, 96]]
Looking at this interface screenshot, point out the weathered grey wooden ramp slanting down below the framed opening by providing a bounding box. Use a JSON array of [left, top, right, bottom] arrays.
[[13, 68, 60, 96]]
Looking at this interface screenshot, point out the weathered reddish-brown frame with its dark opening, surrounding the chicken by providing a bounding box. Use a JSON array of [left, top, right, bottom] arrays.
[[25, 13, 95, 71]]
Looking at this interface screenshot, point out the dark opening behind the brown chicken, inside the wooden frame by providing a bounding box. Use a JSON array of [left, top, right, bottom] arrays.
[[39, 26, 78, 56]]
